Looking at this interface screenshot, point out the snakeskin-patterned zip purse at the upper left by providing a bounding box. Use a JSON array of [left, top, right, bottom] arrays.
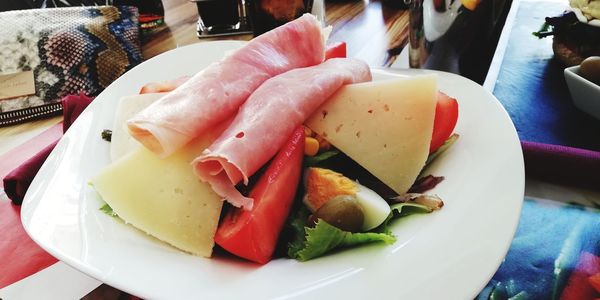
[[0, 6, 142, 126]]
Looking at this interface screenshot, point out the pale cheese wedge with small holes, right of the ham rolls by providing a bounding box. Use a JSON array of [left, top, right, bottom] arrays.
[[306, 75, 437, 194]]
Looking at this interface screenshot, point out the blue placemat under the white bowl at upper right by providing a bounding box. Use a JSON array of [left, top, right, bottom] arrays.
[[493, 1, 600, 151]]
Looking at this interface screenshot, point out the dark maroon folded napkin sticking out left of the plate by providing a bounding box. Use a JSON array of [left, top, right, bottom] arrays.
[[3, 94, 92, 204]]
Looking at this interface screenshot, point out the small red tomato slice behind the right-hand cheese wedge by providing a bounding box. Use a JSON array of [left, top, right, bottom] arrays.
[[429, 92, 458, 153]]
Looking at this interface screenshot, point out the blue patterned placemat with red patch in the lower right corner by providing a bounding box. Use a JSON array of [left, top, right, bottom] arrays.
[[477, 199, 600, 300]]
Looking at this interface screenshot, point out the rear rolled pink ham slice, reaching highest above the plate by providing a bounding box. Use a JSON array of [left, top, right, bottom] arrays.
[[128, 14, 325, 157]]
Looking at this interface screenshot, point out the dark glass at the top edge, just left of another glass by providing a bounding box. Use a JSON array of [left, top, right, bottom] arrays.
[[192, 0, 252, 37]]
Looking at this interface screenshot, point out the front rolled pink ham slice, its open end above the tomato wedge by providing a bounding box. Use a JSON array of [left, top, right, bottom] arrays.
[[192, 58, 371, 209]]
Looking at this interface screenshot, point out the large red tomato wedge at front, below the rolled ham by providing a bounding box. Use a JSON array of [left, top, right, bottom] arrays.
[[215, 126, 304, 264]]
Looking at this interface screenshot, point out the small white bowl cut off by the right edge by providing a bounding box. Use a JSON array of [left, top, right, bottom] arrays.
[[565, 66, 600, 120]]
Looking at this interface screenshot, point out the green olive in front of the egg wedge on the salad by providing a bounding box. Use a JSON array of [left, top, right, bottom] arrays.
[[314, 195, 365, 232]]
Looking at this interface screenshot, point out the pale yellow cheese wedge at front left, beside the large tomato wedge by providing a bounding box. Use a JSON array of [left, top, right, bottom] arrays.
[[91, 126, 224, 257]]
